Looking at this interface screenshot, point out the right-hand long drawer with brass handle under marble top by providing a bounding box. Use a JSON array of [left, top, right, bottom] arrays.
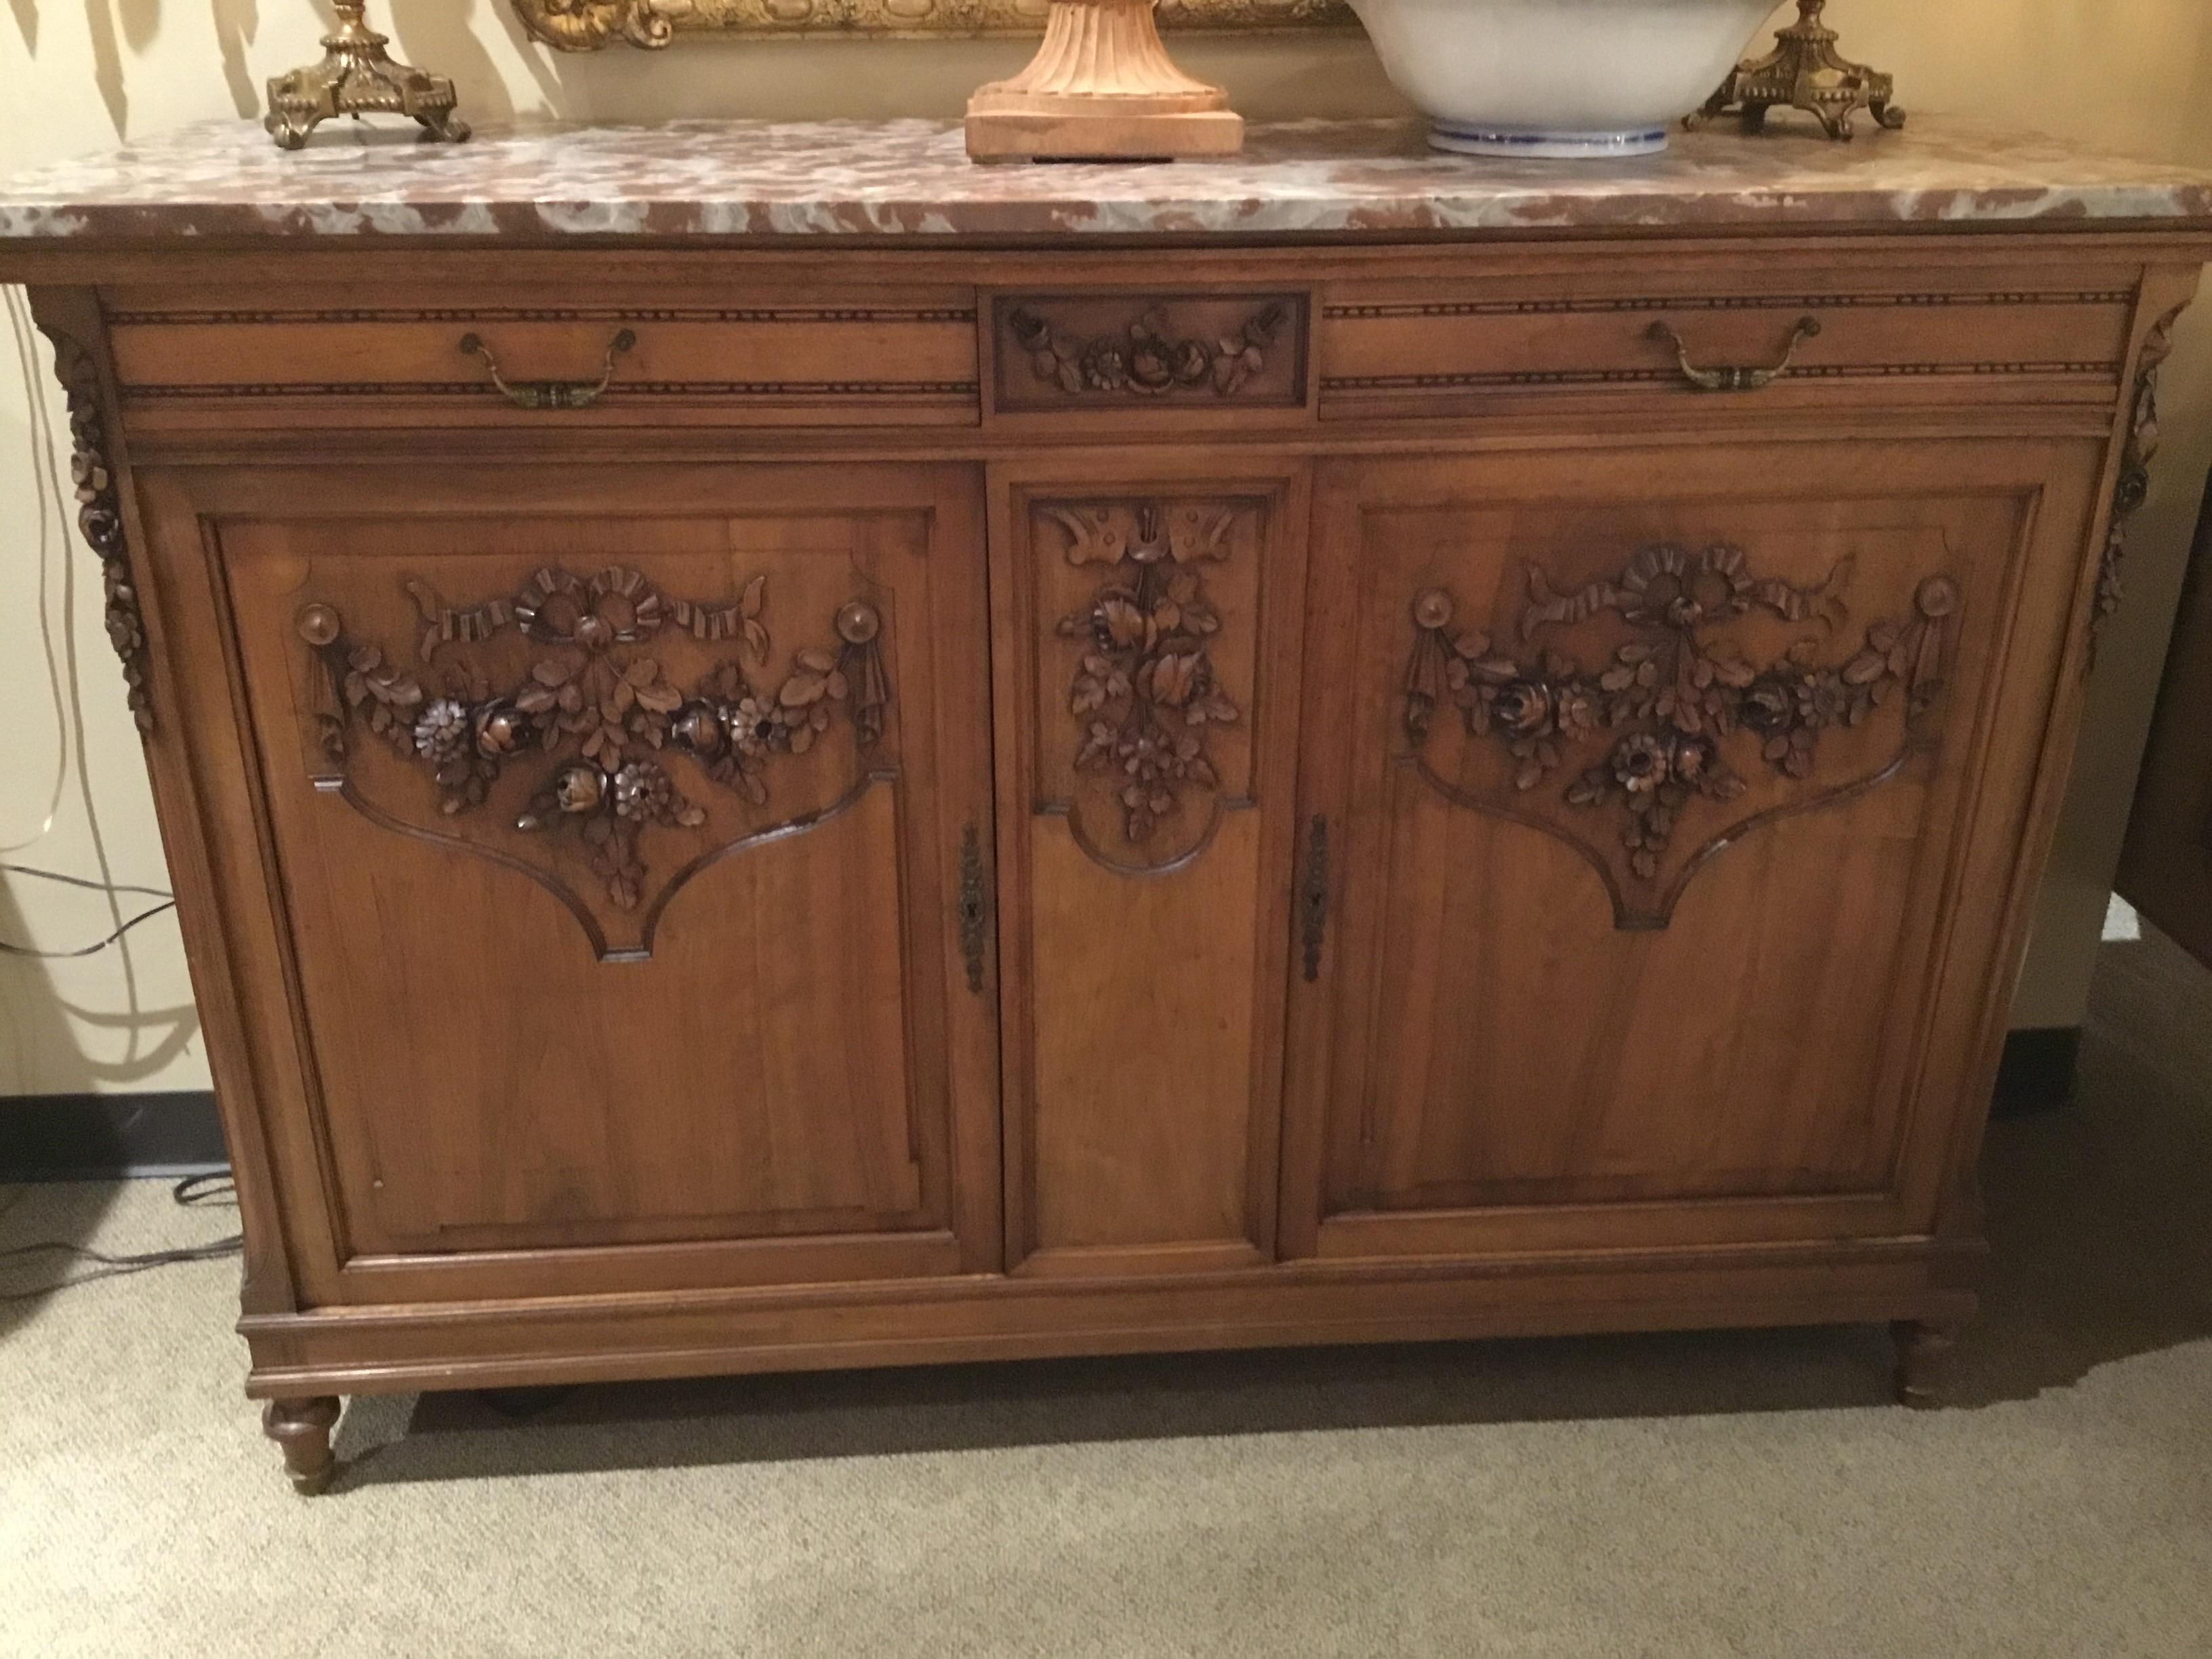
[[1321, 270, 2135, 420]]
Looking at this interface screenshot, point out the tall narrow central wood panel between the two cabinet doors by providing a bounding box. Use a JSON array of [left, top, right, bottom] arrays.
[[994, 467, 1303, 1272]]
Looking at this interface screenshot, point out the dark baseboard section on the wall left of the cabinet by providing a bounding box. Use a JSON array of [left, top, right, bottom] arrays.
[[0, 1088, 230, 1181]]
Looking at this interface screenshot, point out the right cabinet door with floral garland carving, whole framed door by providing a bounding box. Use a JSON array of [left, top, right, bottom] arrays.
[[1281, 438, 2104, 1256]]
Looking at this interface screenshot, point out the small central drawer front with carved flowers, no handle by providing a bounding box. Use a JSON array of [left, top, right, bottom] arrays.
[[991, 290, 1312, 427]]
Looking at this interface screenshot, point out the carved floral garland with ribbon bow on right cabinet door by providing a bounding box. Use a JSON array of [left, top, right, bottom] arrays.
[[1402, 542, 1960, 927]]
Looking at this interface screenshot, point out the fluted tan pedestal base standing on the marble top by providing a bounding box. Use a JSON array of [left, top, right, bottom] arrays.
[[966, 0, 1243, 161]]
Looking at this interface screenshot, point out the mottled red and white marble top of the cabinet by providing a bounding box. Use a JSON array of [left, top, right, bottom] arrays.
[[0, 112, 2212, 248]]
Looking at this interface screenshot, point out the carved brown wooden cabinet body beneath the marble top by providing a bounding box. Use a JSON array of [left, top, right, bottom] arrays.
[[21, 218, 2203, 1484]]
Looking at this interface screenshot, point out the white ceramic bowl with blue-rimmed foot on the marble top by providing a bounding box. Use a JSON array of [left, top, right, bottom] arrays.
[[1351, 0, 1774, 157]]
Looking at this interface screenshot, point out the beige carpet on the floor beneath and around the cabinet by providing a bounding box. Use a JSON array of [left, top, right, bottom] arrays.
[[0, 938, 2212, 1659]]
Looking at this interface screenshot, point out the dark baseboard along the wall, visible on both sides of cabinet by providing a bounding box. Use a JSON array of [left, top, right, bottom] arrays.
[[0, 1026, 2081, 1181]]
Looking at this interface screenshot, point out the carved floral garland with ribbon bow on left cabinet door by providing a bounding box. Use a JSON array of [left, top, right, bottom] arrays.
[[296, 564, 891, 940]]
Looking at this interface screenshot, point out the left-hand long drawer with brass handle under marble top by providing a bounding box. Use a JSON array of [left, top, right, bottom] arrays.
[[106, 287, 978, 427]]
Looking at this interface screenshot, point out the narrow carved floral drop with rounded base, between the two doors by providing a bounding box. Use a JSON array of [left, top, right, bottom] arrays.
[[1033, 500, 1256, 872]]
